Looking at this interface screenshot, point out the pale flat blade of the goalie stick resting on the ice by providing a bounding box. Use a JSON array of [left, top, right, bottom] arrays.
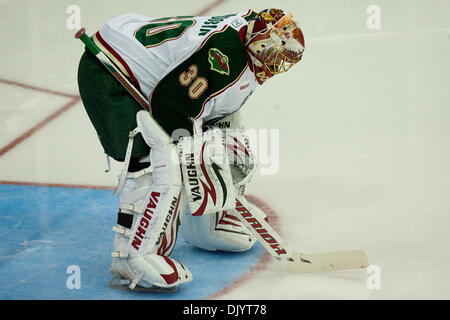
[[286, 250, 369, 272]]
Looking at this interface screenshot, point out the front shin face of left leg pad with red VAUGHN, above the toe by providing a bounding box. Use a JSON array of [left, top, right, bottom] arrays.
[[127, 111, 185, 257]]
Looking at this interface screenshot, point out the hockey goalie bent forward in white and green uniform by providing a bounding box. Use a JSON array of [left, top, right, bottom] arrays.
[[78, 9, 304, 291]]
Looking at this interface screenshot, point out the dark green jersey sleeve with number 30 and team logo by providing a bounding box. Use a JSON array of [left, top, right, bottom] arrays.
[[150, 27, 247, 131]]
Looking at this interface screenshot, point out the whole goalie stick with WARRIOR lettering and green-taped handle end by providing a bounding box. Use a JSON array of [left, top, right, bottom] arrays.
[[75, 28, 369, 272]]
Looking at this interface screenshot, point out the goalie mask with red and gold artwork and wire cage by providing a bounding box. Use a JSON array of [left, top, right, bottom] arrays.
[[245, 9, 305, 84]]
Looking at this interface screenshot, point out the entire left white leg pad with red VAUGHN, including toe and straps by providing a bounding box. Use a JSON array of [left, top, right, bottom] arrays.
[[111, 112, 192, 291]]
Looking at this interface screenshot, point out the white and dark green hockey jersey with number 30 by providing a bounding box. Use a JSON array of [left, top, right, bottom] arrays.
[[94, 10, 257, 134]]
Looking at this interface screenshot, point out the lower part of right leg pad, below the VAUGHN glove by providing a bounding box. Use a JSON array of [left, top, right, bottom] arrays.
[[180, 211, 256, 252]]
